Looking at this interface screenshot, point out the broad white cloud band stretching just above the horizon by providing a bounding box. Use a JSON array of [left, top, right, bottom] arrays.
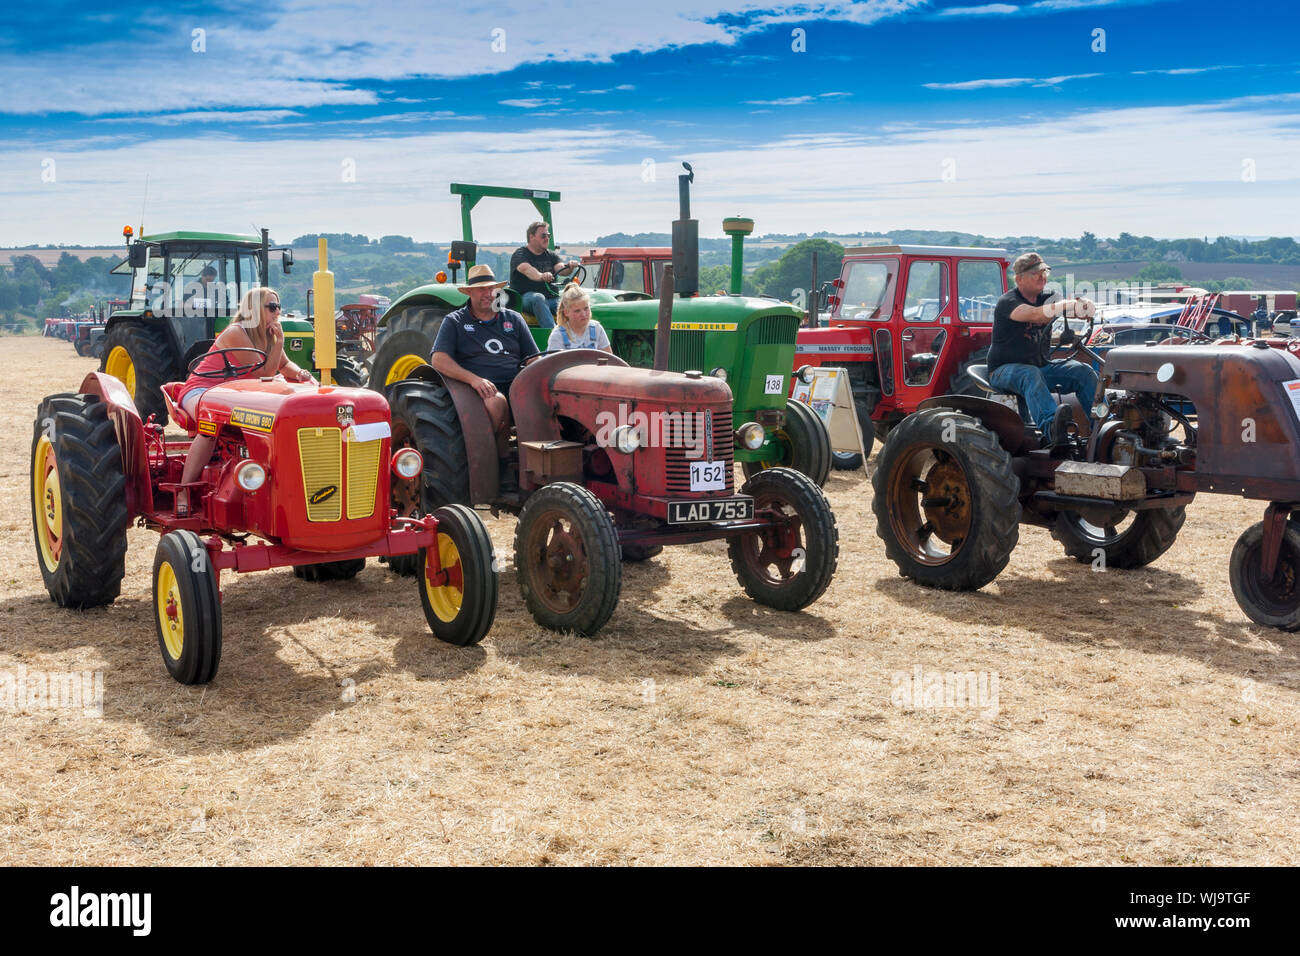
[[10, 94, 1300, 245]]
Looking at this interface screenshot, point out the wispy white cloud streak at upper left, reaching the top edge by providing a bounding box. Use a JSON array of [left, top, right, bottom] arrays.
[[0, 0, 928, 116]]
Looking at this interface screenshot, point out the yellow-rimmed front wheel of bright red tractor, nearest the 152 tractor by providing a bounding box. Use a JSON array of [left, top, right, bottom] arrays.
[[417, 505, 499, 648]]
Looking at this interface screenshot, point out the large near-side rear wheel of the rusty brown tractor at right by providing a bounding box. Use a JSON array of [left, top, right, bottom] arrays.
[[871, 407, 1021, 591]]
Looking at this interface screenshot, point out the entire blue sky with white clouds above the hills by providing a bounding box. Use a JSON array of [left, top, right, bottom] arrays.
[[0, 0, 1300, 245]]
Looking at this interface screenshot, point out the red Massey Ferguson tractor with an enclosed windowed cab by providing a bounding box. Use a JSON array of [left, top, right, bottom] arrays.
[[794, 246, 1008, 468]]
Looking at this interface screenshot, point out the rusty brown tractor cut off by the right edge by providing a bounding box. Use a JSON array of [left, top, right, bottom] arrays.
[[872, 329, 1300, 631]]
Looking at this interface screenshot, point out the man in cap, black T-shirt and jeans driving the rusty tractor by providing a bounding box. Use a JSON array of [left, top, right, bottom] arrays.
[[988, 252, 1097, 446]]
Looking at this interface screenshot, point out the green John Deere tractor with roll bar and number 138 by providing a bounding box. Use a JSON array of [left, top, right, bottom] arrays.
[[369, 175, 831, 485]]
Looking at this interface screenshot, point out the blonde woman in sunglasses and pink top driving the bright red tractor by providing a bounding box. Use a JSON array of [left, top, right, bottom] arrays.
[[176, 286, 316, 518]]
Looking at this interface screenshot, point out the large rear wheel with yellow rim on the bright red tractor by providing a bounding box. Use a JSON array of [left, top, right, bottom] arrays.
[[31, 394, 130, 609]]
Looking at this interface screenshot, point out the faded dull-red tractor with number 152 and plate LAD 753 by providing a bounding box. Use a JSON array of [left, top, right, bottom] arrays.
[[389, 267, 839, 635]]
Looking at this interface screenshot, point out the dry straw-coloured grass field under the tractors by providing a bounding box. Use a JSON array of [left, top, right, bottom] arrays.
[[0, 338, 1300, 865]]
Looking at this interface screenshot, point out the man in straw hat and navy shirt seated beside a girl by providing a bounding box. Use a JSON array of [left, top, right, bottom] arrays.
[[430, 265, 538, 434]]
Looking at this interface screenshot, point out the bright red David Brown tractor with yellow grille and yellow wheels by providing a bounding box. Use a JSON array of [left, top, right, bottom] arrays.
[[31, 240, 497, 684]]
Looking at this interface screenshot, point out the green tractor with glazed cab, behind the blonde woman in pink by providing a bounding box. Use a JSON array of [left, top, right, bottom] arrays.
[[100, 226, 365, 425]]
